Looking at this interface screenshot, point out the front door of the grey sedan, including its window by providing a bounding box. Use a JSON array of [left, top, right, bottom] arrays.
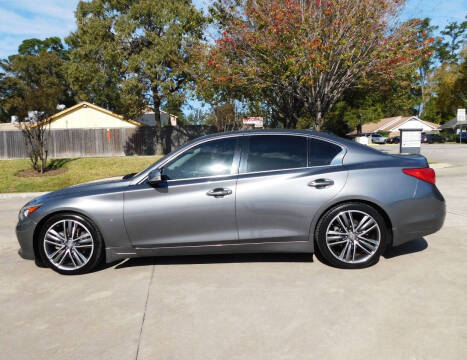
[[124, 136, 240, 248]]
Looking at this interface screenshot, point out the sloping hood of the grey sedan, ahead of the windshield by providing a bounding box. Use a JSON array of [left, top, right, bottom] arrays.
[[27, 177, 130, 205]]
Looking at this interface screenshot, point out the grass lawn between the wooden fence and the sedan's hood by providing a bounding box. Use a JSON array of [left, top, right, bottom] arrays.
[[0, 156, 160, 193]]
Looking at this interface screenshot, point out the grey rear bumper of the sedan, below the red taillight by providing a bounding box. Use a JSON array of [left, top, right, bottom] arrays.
[[393, 180, 446, 246]]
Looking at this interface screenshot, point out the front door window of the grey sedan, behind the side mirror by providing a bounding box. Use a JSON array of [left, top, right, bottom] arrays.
[[163, 137, 237, 180]]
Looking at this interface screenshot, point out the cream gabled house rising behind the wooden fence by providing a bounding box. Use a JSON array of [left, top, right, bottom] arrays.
[[40, 101, 142, 130]]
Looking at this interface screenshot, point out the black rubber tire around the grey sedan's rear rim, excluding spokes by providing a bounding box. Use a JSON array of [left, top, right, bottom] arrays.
[[315, 202, 390, 269]]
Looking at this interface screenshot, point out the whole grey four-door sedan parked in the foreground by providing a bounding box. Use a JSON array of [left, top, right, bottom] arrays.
[[16, 130, 446, 274]]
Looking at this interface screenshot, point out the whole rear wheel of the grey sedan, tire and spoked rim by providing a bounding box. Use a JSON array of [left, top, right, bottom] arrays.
[[315, 202, 390, 269]]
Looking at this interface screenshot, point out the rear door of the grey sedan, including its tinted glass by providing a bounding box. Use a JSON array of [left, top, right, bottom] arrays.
[[236, 134, 347, 242]]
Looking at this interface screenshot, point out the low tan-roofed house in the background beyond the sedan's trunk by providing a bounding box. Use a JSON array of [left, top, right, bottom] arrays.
[[348, 116, 441, 136]]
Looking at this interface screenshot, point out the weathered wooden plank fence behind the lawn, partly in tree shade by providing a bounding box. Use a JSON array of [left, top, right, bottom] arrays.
[[0, 125, 216, 160]]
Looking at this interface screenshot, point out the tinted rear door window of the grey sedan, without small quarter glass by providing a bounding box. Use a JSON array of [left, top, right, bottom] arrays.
[[246, 135, 307, 172]]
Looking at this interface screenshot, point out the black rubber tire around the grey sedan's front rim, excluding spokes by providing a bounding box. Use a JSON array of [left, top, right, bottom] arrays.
[[38, 213, 104, 275]]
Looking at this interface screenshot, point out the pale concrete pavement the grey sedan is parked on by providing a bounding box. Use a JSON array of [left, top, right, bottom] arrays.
[[0, 145, 467, 360]]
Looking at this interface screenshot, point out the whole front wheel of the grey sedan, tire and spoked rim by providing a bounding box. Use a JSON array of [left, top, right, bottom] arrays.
[[38, 214, 104, 275]]
